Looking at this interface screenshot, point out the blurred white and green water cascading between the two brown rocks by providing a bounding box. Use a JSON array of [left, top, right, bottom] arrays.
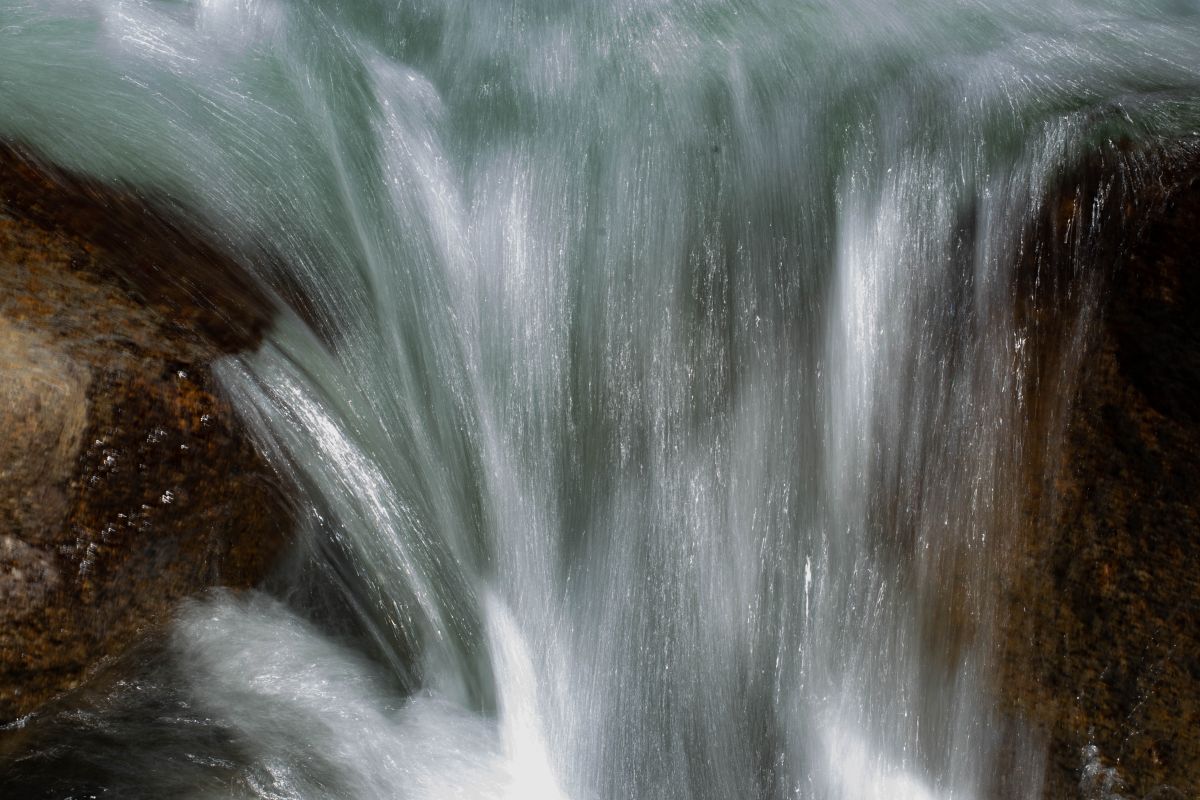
[[0, 0, 1200, 800]]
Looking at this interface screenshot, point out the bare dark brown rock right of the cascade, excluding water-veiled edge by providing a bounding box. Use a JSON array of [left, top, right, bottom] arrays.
[[1003, 148, 1200, 800]]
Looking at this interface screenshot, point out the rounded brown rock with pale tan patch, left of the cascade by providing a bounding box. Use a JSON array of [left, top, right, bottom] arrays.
[[0, 145, 292, 722]]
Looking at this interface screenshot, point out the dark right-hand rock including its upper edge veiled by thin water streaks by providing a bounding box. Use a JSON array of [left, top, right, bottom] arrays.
[[1000, 138, 1200, 798]]
